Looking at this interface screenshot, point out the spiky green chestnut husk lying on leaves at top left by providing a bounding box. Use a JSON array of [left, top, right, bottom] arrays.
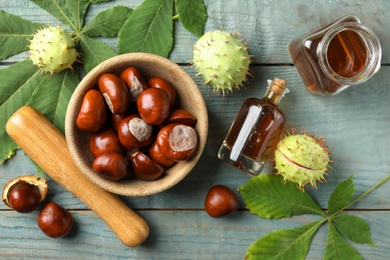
[[29, 26, 78, 74]]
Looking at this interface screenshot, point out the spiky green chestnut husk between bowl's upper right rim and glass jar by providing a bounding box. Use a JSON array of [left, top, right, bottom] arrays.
[[192, 30, 251, 94]]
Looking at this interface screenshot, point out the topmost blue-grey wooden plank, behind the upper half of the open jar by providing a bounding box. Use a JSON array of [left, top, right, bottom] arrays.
[[0, 0, 390, 64]]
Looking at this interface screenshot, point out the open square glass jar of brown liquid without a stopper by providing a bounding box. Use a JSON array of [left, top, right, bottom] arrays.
[[288, 15, 382, 95]]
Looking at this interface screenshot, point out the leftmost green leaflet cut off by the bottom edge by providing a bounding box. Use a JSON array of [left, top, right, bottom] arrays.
[[245, 219, 325, 260]]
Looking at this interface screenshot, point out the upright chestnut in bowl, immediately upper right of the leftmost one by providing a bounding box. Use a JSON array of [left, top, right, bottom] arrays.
[[98, 73, 130, 114]]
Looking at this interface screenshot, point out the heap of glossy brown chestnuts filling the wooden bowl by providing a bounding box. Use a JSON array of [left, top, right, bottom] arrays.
[[76, 66, 198, 181]]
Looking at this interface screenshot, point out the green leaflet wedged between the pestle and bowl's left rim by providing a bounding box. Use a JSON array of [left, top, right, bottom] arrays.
[[26, 67, 80, 133]]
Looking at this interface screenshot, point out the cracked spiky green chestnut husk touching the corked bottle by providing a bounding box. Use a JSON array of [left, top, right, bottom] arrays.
[[275, 134, 330, 190]]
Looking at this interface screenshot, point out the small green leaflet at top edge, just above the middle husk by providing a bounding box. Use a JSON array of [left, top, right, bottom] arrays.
[[176, 0, 207, 38]]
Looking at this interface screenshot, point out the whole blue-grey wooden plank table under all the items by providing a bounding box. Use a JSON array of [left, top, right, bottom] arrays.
[[0, 0, 390, 259]]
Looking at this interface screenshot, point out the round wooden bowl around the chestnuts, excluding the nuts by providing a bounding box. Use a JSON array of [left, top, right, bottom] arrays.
[[65, 53, 208, 196]]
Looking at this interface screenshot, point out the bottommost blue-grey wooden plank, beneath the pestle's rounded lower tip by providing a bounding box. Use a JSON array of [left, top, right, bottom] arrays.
[[0, 210, 390, 259]]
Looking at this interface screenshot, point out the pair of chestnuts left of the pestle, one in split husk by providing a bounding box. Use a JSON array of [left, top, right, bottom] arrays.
[[2, 175, 73, 238]]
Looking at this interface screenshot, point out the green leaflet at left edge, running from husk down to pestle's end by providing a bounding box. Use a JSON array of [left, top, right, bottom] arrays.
[[0, 60, 48, 165]]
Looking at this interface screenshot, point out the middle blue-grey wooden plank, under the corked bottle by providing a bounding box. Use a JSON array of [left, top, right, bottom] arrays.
[[0, 66, 390, 209]]
